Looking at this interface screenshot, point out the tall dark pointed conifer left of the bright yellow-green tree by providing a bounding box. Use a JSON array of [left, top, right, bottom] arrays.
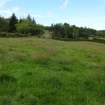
[[9, 13, 18, 32]]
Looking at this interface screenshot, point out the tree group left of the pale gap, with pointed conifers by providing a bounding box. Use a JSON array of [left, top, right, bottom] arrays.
[[0, 13, 44, 36]]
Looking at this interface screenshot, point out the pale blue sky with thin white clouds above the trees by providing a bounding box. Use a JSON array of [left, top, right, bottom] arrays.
[[0, 0, 105, 30]]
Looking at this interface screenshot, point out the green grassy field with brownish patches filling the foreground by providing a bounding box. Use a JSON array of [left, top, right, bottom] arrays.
[[0, 38, 105, 105]]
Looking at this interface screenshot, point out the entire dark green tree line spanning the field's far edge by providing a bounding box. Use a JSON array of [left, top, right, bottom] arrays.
[[0, 13, 105, 40]]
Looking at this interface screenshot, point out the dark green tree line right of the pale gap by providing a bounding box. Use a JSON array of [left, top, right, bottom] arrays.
[[48, 23, 105, 40]]
